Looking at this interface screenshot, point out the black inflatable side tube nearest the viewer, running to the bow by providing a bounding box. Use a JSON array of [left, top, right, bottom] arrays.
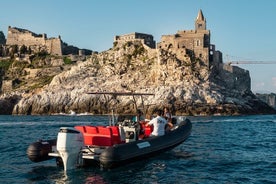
[[100, 119, 192, 169]]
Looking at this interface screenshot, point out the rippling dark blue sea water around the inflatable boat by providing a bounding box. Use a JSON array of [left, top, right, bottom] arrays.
[[0, 115, 276, 184]]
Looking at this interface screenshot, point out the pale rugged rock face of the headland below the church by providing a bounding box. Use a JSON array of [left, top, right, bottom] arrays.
[[9, 42, 275, 115]]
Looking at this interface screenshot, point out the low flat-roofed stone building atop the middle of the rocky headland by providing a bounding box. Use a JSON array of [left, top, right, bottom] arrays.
[[114, 32, 155, 48]]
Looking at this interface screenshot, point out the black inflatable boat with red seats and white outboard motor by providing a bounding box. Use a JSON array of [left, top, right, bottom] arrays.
[[27, 119, 192, 171]]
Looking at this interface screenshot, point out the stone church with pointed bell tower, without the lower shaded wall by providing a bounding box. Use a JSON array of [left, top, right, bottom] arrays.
[[157, 10, 222, 67]]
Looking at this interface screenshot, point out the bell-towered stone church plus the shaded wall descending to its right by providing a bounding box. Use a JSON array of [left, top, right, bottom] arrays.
[[157, 10, 251, 91]]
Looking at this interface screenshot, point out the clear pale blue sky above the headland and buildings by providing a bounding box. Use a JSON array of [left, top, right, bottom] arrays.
[[0, 0, 276, 93]]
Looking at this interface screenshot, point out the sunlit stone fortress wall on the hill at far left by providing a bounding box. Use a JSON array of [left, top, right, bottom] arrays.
[[6, 26, 62, 56]]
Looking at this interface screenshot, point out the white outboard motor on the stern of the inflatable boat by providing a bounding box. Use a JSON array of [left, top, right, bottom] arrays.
[[57, 127, 83, 171]]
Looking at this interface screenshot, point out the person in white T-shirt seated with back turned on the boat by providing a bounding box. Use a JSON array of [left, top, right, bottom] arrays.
[[146, 109, 168, 136]]
